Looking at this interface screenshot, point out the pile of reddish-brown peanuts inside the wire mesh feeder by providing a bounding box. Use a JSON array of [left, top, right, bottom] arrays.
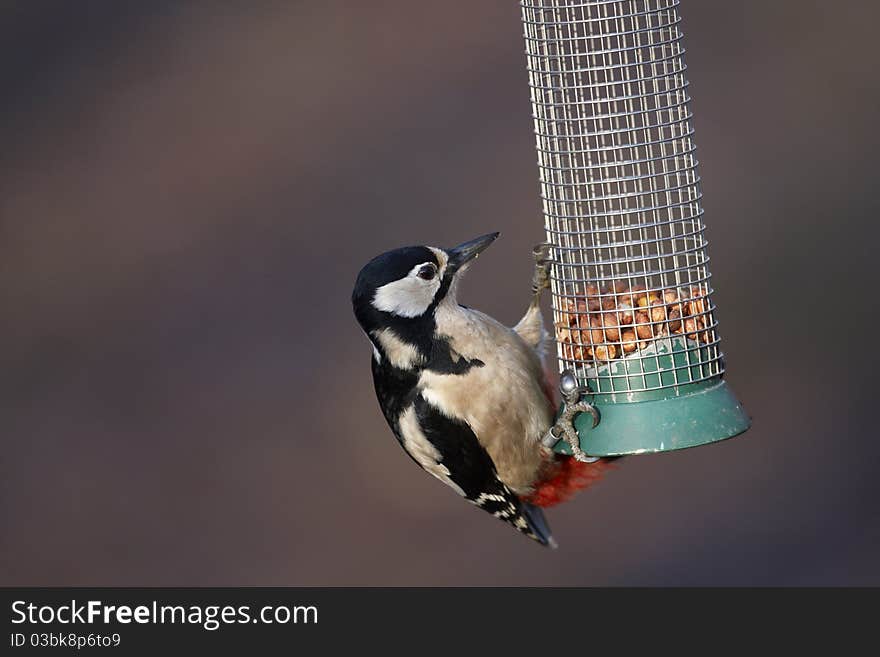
[[555, 281, 713, 362]]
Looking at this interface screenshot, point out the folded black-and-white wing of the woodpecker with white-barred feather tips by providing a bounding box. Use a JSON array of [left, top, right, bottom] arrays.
[[398, 395, 555, 546]]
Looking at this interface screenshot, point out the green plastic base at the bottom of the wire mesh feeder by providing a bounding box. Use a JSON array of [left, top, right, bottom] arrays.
[[555, 340, 751, 456]]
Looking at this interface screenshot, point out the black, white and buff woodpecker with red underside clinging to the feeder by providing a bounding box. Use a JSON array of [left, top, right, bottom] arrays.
[[352, 233, 607, 547]]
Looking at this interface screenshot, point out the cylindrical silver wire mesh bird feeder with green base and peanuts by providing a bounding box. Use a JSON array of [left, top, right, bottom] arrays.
[[521, 0, 750, 456]]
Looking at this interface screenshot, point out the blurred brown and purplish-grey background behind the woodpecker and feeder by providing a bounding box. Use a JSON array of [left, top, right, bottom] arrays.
[[0, 0, 880, 585]]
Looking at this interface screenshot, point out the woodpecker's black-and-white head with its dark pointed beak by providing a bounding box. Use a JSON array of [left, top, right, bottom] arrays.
[[351, 233, 498, 348]]
